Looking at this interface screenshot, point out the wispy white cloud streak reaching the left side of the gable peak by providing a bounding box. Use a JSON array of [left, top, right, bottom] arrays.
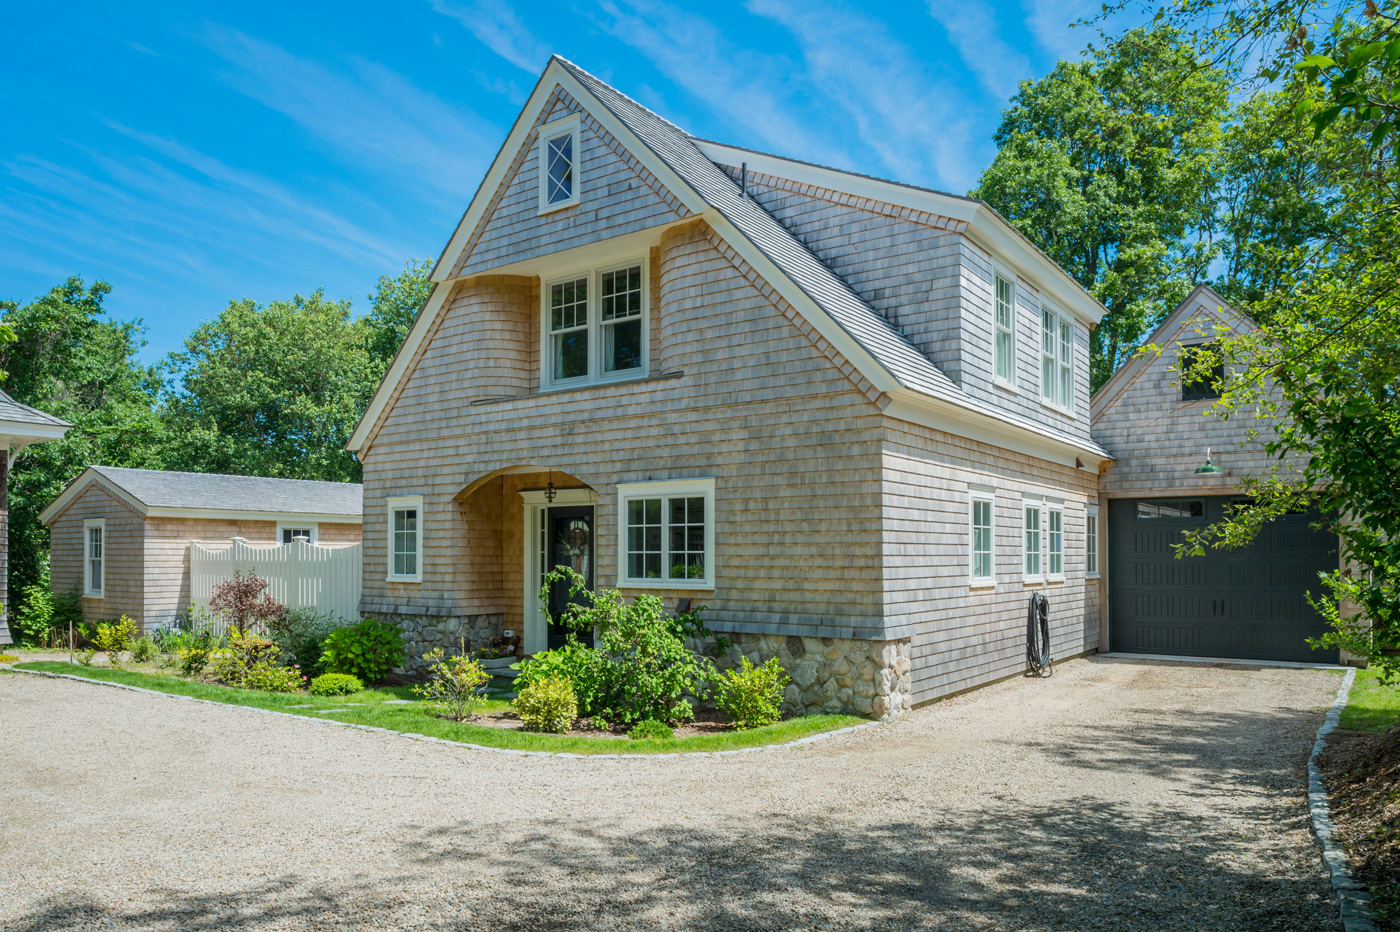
[[204, 25, 501, 197]]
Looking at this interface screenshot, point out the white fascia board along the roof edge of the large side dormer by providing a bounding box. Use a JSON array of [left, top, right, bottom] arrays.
[[696, 140, 1107, 326]]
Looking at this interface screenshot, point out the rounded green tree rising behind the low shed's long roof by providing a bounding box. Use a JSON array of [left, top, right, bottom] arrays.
[[161, 291, 382, 481]]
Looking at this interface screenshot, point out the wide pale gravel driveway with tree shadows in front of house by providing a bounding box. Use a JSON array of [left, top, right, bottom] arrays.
[[0, 658, 1340, 932]]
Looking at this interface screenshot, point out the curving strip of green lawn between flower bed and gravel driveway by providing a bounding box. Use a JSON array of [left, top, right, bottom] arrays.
[[15, 661, 864, 754]]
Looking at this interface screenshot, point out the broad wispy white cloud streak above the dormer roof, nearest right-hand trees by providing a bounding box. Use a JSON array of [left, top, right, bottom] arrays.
[[748, 0, 980, 192]]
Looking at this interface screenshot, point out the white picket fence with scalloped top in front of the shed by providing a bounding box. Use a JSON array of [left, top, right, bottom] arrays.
[[189, 537, 361, 620]]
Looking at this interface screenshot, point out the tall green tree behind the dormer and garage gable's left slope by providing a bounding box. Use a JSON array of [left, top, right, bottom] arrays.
[[973, 28, 1229, 388]]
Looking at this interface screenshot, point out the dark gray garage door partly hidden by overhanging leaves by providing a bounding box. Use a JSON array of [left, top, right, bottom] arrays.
[[1109, 497, 1337, 663]]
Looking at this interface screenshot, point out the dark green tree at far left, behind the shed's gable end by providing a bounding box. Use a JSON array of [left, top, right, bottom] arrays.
[[0, 277, 161, 607]]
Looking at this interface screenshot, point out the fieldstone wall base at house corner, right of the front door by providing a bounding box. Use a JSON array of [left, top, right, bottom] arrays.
[[714, 634, 913, 722]]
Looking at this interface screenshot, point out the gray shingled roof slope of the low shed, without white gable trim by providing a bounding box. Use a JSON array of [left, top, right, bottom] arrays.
[[91, 466, 364, 515]]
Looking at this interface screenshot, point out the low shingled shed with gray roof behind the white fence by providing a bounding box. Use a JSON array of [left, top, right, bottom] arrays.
[[39, 466, 361, 630]]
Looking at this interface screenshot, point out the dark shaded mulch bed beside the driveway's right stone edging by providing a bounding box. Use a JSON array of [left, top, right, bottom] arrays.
[[1319, 725, 1400, 932]]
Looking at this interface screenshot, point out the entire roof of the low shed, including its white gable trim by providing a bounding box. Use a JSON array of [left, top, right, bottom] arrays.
[[39, 466, 364, 525]]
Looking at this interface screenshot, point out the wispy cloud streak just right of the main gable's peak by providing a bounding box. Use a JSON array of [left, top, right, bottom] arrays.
[[599, 0, 850, 167]]
